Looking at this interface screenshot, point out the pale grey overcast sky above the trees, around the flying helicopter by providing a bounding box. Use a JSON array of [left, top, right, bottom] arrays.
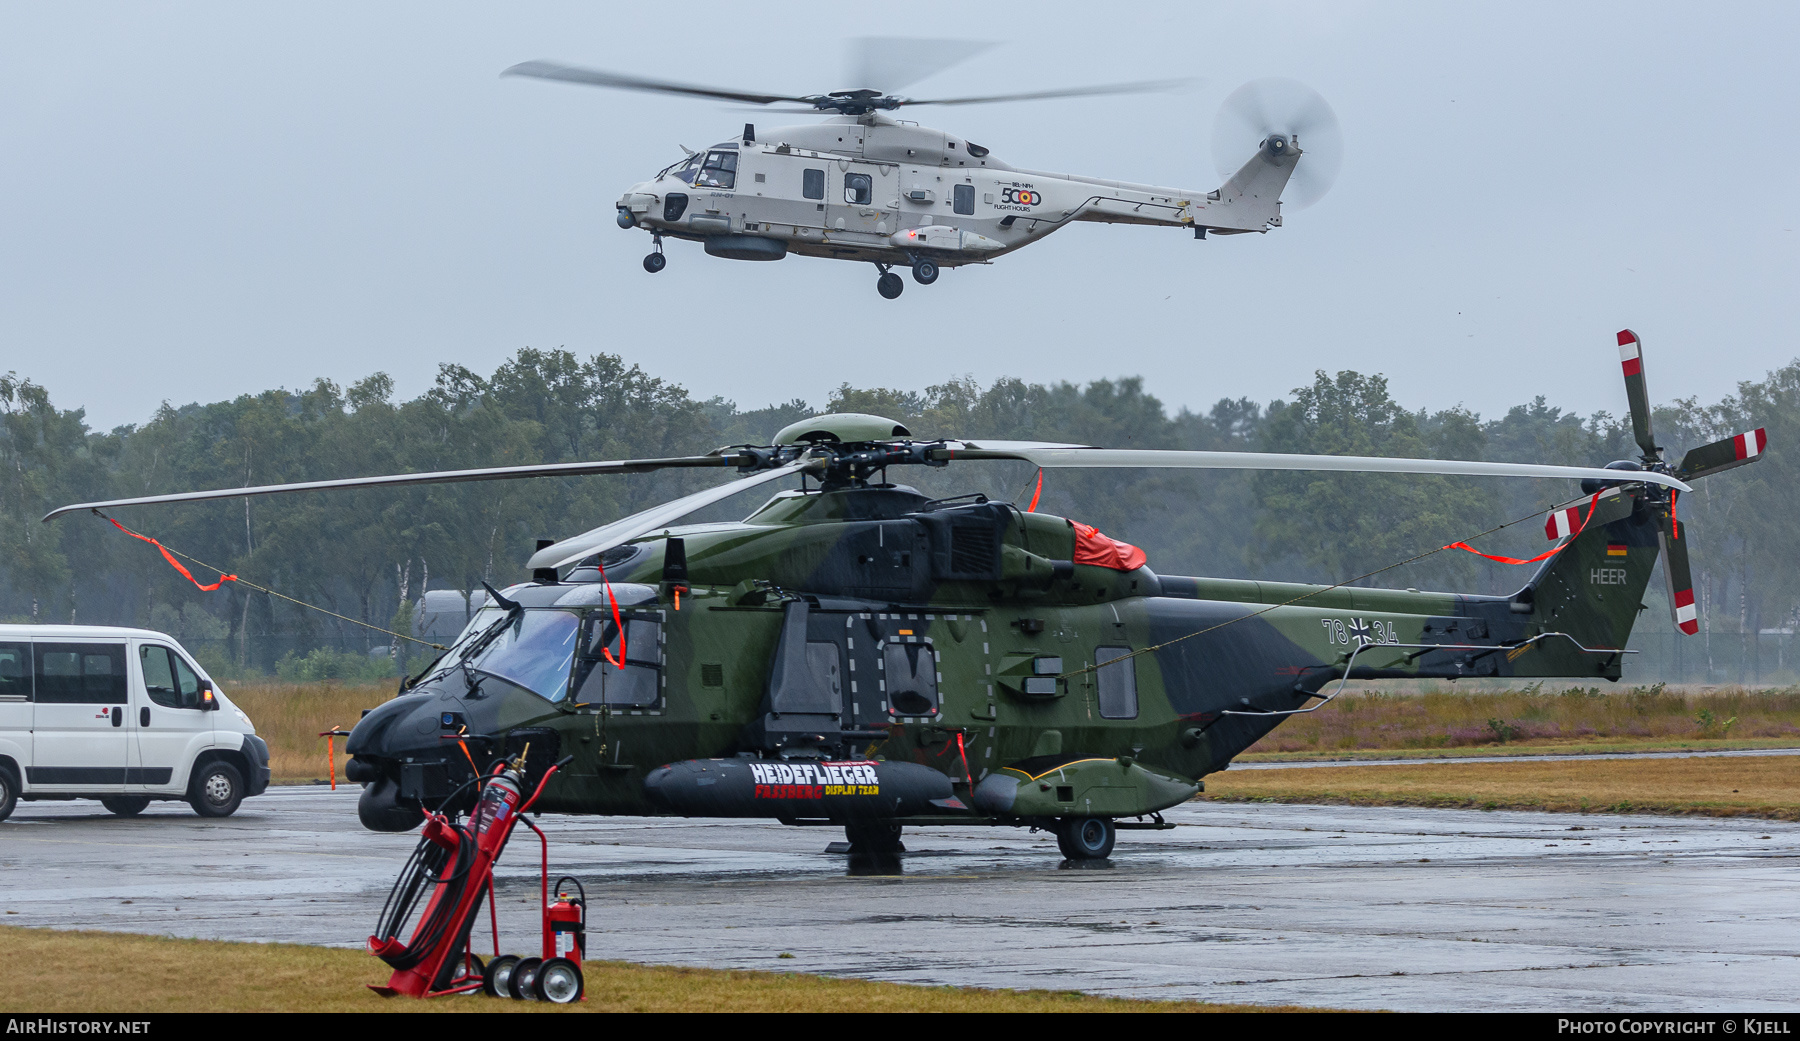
[[0, 0, 1800, 427]]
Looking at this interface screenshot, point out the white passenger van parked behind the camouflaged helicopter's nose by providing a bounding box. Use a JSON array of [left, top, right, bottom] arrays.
[[0, 625, 268, 821]]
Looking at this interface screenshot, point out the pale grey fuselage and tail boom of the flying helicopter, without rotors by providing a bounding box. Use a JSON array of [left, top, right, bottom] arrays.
[[617, 112, 1301, 271]]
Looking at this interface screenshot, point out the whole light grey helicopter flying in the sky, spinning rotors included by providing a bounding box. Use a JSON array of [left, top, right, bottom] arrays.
[[502, 38, 1339, 299]]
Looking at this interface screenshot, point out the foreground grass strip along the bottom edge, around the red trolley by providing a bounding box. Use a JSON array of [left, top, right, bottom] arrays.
[[0, 928, 1312, 1012]]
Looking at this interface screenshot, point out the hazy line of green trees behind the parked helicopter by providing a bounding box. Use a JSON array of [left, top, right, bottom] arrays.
[[0, 348, 1800, 679]]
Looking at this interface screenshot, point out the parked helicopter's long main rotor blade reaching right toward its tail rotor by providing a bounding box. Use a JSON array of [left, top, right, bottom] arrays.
[[950, 448, 1692, 492]]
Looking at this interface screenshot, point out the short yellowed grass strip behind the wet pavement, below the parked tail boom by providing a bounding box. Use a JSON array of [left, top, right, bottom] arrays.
[[1201, 756, 1800, 821]]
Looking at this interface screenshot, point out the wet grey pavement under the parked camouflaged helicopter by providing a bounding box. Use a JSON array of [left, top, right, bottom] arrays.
[[0, 787, 1800, 1010]]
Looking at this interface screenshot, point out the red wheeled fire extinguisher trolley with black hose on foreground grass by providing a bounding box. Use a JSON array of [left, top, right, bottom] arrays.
[[369, 753, 587, 1005]]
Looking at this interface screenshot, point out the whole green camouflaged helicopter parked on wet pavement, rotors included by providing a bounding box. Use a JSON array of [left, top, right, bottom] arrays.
[[47, 331, 1764, 859]]
